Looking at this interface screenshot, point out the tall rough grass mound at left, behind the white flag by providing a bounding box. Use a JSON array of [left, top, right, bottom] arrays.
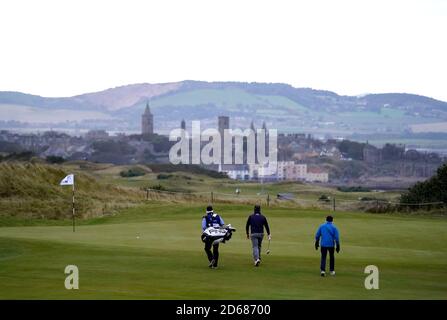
[[0, 162, 143, 219]]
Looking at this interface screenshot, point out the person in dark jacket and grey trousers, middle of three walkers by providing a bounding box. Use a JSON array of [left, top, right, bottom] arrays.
[[245, 205, 272, 267]]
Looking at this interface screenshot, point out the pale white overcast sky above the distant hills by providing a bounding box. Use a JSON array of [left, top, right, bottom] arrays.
[[0, 0, 447, 101]]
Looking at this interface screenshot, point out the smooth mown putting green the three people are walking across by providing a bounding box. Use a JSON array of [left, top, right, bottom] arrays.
[[0, 202, 447, 299]]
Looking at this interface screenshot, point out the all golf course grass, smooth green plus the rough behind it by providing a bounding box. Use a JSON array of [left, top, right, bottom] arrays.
[[0, 162, 447, 299]]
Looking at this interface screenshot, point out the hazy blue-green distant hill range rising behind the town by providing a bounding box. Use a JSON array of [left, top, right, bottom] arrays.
[[0, 81, 447, 135]]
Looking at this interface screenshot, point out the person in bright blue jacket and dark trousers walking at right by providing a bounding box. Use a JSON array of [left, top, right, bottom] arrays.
[[315, 216, 340, 277]]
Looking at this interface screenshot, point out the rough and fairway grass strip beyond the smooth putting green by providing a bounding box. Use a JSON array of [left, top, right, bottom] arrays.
[[0, 161, 399, 220]]
